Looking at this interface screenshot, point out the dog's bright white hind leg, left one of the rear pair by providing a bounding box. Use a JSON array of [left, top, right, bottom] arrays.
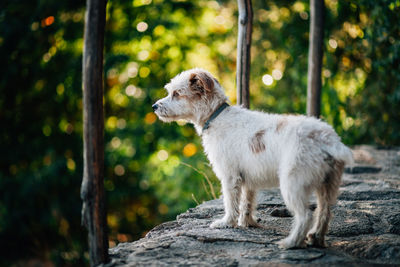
[[278, 175, 312, 249]]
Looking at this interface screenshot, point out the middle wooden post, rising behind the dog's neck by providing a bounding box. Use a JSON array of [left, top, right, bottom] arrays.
[[236, 0, 253, 108]]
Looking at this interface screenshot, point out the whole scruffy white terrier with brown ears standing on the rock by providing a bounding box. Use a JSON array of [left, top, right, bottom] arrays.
[[152, 69, 352, 248]]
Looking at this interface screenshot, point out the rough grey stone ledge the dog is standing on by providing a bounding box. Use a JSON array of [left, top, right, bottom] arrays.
[[107, 146, 400, 266]]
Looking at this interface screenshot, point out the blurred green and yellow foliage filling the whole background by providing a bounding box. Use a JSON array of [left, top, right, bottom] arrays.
[[0, 0, 400, 265]]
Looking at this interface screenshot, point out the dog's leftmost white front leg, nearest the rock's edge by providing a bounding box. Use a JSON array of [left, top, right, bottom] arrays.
[[210, 177, 242, 228]]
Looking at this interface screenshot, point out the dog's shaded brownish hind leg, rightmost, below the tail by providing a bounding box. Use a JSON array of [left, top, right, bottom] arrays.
[[306, 160, 344, 247]]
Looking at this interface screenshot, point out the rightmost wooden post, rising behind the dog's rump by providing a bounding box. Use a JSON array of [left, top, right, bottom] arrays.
[[307, 0, 325, 118]]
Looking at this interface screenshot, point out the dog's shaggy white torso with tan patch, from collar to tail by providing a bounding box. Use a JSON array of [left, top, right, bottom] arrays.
[[203, 106, 351, 187]]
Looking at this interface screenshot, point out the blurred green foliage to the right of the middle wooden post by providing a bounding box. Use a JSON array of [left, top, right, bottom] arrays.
[[251, 0, 400, 146]]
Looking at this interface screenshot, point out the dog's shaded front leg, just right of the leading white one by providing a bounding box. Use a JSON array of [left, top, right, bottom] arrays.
[[238, 185, 261, 227]]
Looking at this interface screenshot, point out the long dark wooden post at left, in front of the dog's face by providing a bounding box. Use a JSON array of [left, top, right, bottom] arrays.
[[81, 0, 108, 266]]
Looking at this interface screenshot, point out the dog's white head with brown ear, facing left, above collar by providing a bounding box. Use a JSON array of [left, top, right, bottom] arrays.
[[152, 69, 227, 124]]
